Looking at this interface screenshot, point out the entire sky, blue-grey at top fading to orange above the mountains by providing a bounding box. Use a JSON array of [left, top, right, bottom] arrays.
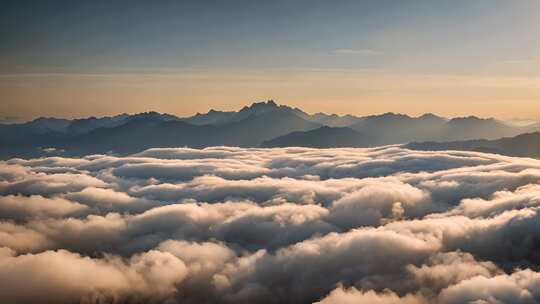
[[0, 0, 540, 120]]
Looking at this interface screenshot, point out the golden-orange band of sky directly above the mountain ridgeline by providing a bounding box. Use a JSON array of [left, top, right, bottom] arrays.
[[0, 70, 540, 120]]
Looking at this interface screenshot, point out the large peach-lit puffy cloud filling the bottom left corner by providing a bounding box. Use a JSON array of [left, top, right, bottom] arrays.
[[0, 247, 187, 303]]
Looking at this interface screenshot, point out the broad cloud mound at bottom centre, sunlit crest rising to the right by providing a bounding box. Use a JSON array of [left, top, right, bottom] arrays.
[[217, 228, 437, 303]]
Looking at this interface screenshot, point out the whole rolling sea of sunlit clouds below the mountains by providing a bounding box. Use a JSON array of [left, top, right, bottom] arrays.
[[0, 146, 540, 304]]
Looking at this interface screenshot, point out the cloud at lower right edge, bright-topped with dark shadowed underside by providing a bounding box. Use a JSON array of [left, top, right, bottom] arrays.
[[383, 209, 540, 270]]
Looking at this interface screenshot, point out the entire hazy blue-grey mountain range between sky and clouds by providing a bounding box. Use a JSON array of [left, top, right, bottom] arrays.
[[0, 100, 540, 159]]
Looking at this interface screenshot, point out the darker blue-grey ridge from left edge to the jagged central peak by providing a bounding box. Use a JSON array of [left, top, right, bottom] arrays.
[[0, 101, 321, 159]]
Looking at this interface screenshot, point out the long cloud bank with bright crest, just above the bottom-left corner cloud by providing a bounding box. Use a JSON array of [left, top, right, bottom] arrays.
[[19, 202, 338, 254]]
